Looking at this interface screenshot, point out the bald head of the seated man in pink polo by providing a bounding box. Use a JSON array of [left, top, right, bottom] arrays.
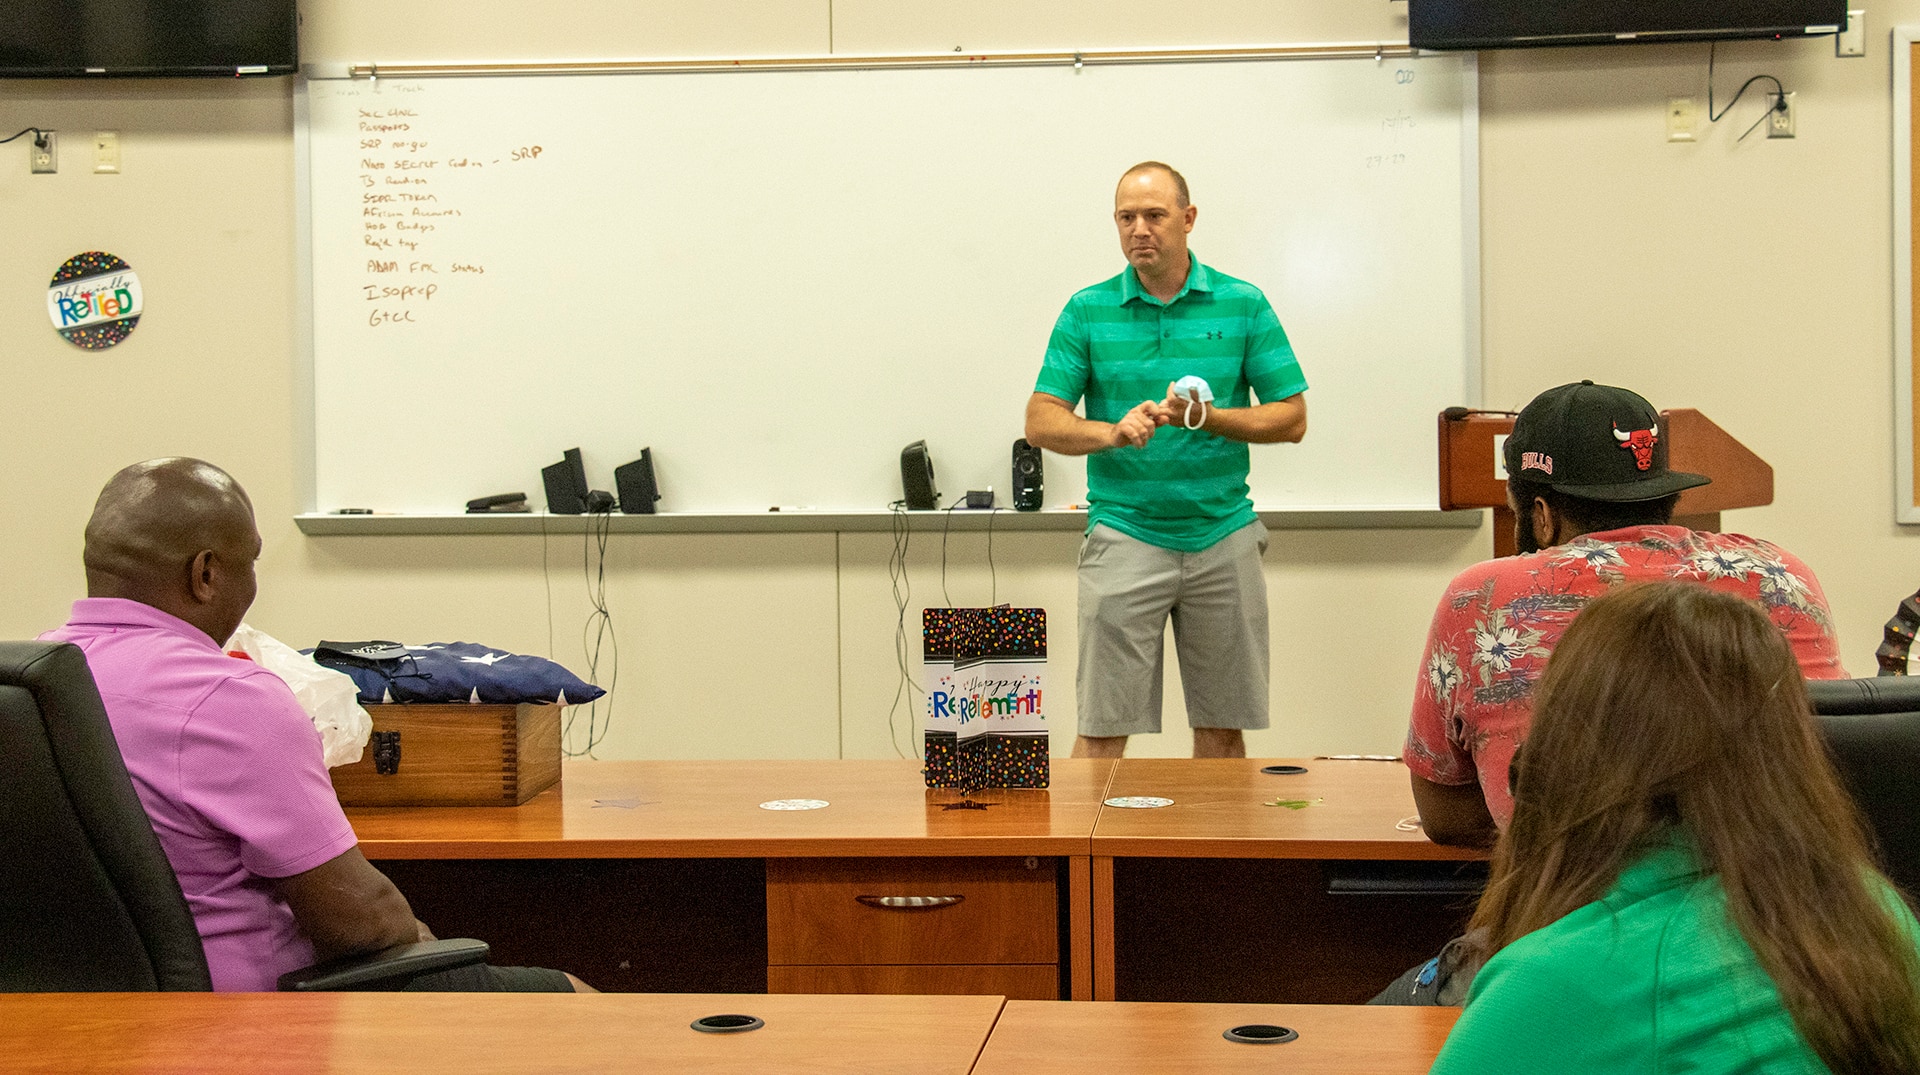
[[84, 459, 259, 643]]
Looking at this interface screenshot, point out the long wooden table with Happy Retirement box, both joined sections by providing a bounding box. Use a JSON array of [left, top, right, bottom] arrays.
[[348, 758, 1476, 1002]]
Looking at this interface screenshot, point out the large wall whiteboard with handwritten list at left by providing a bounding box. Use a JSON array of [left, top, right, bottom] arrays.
[[298, 56, 1478, 514]]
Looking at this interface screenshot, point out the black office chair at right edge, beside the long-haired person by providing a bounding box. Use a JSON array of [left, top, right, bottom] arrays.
[[1807, 676, 1920, 896]]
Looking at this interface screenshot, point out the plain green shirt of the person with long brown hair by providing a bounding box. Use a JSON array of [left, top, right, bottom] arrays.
[[1432, 841, 1916, 1075]]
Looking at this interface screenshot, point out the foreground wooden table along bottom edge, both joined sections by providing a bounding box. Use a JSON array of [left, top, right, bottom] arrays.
[[0, 992, 1455, 1075]]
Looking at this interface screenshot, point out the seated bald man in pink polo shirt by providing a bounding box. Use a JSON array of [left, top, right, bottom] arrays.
[[42, 459, 589, 992]]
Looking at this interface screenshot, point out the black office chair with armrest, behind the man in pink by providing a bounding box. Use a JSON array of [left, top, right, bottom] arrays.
[[0, 641, 488, 992]]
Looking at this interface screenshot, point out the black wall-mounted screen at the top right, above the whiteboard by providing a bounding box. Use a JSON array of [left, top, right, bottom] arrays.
[[1407, 0, 1849, 48]]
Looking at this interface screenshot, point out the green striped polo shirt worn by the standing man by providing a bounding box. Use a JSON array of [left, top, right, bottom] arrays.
[[1035, 259, 1308, 553]]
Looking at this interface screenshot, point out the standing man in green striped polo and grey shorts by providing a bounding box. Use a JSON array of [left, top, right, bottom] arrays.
[[1027, 161, 1308, 758]]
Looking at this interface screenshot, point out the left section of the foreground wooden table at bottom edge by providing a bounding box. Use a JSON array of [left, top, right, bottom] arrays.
[[0, 992, 1000, 1075]]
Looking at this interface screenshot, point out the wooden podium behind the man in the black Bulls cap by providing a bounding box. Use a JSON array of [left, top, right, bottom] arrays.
[[1440, 409, 1774, 557]]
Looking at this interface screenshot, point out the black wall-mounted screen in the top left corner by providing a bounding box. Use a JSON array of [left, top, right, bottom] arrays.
[[0, 0, 298, 79]]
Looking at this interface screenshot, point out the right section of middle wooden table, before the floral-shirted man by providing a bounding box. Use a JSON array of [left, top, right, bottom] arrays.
[[1091, 758, 1486, 1004]]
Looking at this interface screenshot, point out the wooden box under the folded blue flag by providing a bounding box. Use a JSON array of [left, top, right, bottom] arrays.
[[332, 703, 561, 806]]
